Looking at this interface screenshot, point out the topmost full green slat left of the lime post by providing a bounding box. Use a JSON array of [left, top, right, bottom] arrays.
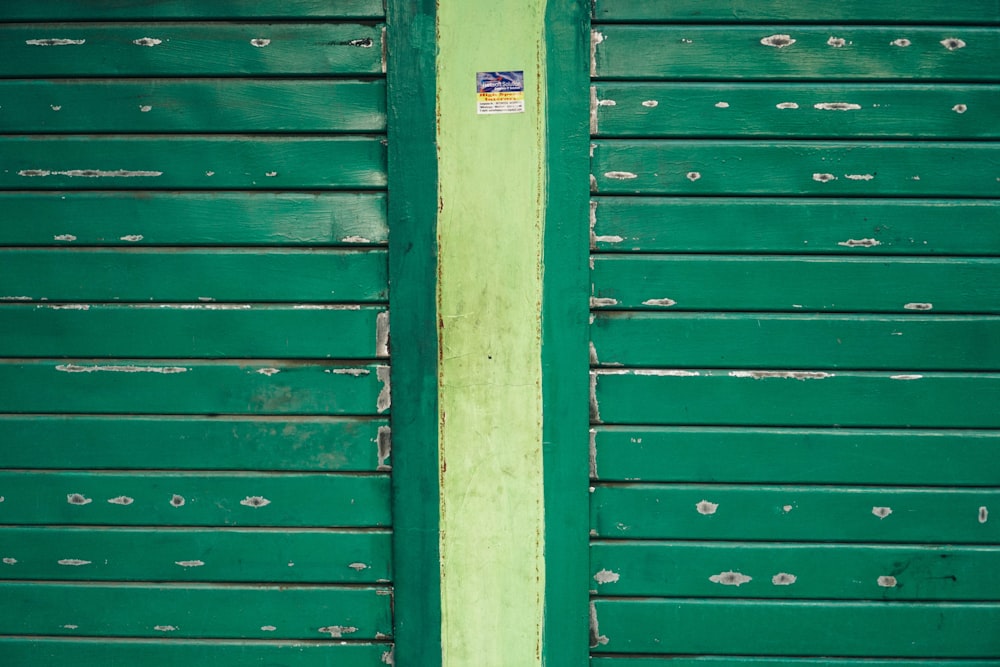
[[0, 22, 383, 78]]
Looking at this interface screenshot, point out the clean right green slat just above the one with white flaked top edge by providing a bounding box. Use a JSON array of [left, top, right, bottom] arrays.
[[588, 309, 1000, 371]]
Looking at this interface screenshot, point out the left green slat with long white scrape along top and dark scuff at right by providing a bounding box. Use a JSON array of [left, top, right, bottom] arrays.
[[0, 360, 389, 416]]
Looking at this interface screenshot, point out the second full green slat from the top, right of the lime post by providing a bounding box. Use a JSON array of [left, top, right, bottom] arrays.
[[591, 82, 1000, 139]]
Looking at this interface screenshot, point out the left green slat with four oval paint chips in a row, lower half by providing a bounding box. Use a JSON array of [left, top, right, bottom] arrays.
[[0, 472, 390, 528]]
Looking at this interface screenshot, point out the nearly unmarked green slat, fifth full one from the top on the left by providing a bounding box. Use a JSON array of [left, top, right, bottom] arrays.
[[0, 249, 388, 303]]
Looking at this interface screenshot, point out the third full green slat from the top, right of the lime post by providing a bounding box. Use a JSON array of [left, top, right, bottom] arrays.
[[591, 139, 1000, 197]]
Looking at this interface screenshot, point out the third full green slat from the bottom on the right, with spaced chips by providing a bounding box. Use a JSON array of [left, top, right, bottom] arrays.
[[590, 484, 1000, 544]]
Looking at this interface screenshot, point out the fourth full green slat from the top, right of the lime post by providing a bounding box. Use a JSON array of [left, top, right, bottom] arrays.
[[591, 197, 1000, 255]]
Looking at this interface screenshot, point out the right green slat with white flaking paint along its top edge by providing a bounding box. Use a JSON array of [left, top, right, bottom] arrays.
[[591, 369, 1000, 428]]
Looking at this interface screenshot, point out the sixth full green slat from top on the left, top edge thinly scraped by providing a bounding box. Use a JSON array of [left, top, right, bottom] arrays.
[[0, 304, 388, 359]]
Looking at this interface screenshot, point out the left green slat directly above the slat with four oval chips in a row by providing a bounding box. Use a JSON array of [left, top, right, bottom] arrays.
[[0, 415, 391, 472]]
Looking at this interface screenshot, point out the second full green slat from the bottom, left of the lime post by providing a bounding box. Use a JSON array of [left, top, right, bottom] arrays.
[[0, 527, 392, 584]]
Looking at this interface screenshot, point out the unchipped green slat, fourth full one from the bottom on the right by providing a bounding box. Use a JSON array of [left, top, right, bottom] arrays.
[[593, 426, 1000, 486]]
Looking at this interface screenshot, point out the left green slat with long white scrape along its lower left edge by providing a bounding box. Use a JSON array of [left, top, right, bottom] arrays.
[[0, 135, 385, 190]]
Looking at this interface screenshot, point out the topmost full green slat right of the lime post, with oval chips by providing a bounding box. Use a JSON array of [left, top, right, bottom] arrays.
[[592, 24, 1000, 81]]
